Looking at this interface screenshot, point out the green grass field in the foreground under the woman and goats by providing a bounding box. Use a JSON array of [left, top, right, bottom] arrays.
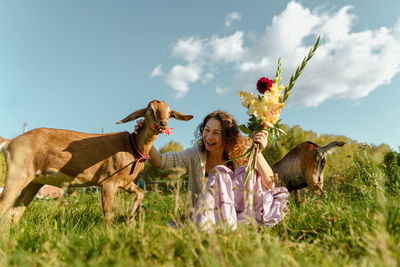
[[0, 152, 400, 266]]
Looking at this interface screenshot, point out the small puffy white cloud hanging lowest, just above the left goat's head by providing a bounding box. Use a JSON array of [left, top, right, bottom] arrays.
[[166, 64, 202, 98]]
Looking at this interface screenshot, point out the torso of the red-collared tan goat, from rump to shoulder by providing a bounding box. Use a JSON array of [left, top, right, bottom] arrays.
[[6, 128, 133, 185]]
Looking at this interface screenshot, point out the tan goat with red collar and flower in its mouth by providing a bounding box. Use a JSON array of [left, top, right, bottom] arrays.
[[0, 100, 193, 225]]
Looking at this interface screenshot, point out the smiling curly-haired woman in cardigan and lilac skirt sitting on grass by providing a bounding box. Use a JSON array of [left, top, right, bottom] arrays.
[[144, 110, 288, 228]]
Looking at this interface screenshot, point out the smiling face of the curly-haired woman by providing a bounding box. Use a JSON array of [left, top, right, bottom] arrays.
[[203, 118, 225, 153]]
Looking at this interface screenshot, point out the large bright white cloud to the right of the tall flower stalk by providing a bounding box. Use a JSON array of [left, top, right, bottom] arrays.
[[289, 4, 400, 106]]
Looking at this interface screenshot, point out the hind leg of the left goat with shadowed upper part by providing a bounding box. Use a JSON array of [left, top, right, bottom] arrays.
[[9, 183, 43, 223]]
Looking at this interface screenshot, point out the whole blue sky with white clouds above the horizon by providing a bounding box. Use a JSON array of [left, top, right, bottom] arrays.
[[0, 0, 400, 150]]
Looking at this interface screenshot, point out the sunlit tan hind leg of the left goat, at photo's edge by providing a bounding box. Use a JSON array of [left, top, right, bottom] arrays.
[[0, 168, 33, 222]]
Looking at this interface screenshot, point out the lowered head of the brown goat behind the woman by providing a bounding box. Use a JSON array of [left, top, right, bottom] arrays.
[[302, 141, 346, 196]]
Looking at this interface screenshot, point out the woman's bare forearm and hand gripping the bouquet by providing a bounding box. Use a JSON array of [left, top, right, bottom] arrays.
[[253, 131, 275, 189]]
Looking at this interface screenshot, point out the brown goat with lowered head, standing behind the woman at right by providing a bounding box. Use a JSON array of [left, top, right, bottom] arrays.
[[272, 141, 346, 202]]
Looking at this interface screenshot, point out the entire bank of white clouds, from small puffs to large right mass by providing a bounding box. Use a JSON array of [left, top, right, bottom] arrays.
[[155, 1, 400, 106]]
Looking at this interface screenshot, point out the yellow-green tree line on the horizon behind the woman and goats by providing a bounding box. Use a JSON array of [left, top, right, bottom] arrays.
[[0, 124, 400, 186]]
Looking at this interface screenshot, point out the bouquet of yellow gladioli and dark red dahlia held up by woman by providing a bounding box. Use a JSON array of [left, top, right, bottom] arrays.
[[239, 37, 320, 185]]
